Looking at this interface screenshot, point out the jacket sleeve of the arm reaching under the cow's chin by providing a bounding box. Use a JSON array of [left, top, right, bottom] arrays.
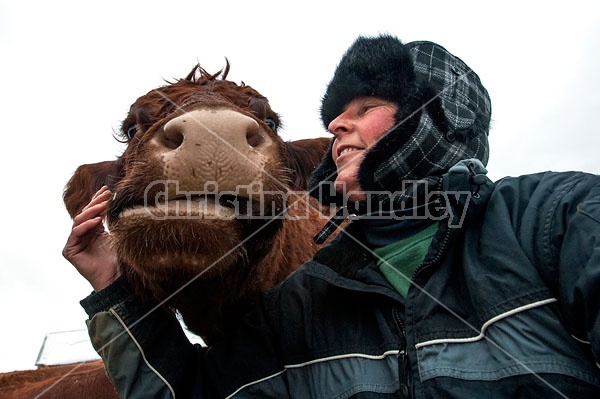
[[81, 279, 286, 398]]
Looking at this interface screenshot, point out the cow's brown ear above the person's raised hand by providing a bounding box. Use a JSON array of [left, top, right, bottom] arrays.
[[63, 160, 123, 218]]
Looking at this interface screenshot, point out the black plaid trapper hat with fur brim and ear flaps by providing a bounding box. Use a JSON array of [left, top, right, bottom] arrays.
[[309, 35, 491, 206]]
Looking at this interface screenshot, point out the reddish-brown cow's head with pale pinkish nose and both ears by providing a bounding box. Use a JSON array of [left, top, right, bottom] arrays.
[[64, 65, 329, 339]]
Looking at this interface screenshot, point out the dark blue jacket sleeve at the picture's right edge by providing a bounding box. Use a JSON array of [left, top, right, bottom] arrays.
[[523, 172, 600, 367]]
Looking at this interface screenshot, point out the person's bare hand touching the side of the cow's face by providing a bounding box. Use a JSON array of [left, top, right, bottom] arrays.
[[62, 186, 120, 291]]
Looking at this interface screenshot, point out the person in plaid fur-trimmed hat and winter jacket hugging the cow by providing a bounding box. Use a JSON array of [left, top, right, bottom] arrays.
[[63, 34, 600, 398]]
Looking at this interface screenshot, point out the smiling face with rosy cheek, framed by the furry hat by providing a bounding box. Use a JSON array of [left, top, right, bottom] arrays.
[[328, 97, 398, 201]]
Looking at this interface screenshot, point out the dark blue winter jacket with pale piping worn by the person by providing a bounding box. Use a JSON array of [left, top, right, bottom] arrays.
[[82, 162, 600, 399]]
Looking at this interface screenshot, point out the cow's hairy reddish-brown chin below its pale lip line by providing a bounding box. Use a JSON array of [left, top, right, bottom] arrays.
[[110, 207, 246, 299]]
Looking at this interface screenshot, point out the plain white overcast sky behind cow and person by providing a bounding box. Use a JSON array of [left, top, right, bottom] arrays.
[[0, 0, 600, 371]]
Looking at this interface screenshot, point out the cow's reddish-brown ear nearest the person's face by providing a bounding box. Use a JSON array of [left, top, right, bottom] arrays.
[[283, 137, 331, 190]]
